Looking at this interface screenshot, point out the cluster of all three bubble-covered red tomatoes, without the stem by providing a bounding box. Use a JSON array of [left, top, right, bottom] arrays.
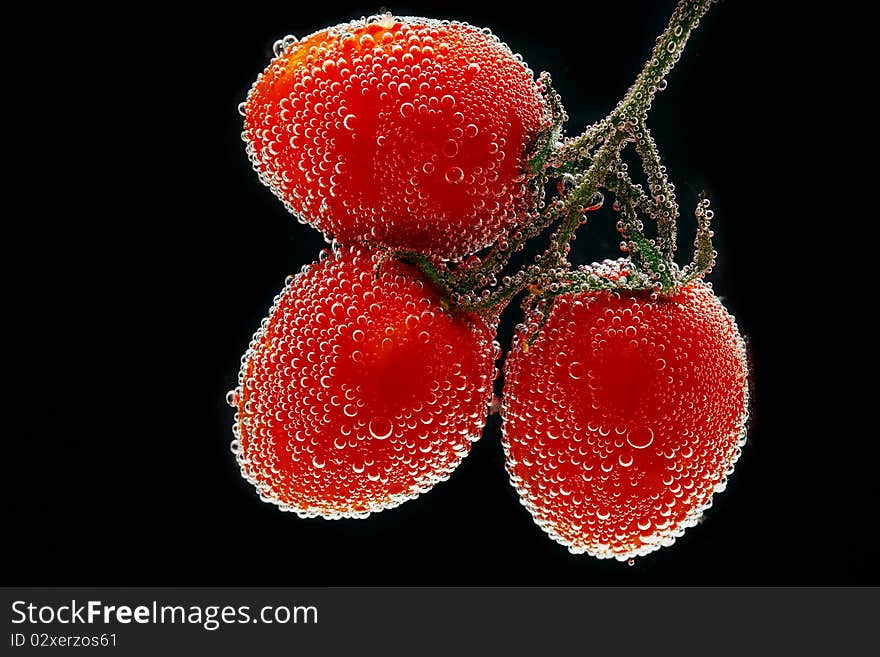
[[229, 15, 748, 559]]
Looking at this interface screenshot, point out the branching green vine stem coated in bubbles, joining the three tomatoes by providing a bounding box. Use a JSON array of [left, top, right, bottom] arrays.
[[405, 0, 713, 311]]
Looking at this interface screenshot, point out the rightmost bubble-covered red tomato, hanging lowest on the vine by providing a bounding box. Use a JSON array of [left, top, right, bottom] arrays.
[[502, 274, 748, 560]]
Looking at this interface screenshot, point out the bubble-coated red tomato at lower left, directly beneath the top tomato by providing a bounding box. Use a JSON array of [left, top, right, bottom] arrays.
[[227, 249, 498, 518]]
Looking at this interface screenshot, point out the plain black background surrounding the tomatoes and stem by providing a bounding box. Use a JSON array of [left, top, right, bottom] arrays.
[[10, 1, 880, 586]]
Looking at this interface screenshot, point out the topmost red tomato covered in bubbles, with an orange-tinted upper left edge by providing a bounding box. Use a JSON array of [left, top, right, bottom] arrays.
[[241, 15, 545, 258]]
